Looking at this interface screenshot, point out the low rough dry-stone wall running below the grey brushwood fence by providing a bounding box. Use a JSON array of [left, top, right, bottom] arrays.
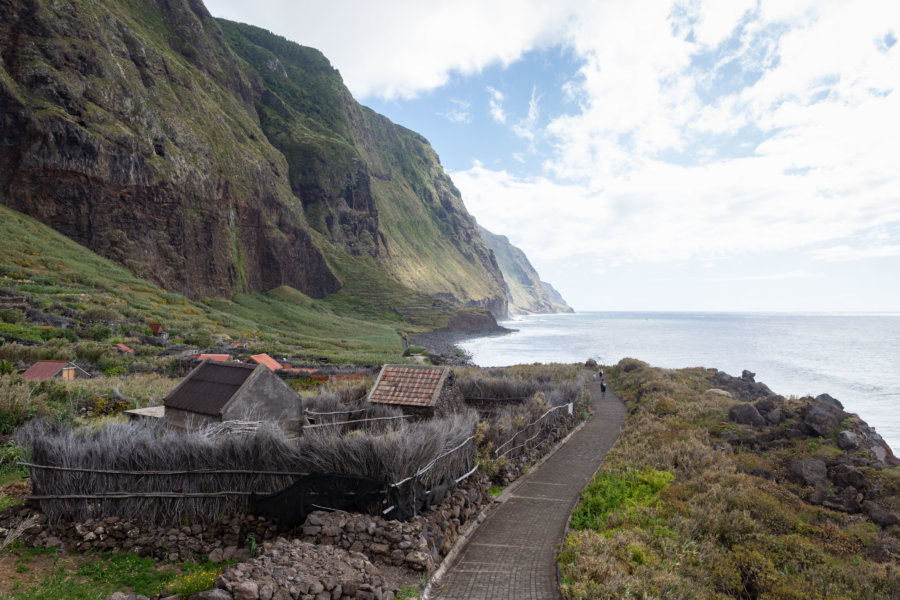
[[0, 474, 490, 572]]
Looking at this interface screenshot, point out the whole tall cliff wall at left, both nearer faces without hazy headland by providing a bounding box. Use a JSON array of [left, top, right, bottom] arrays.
[[0, 0, 506, 316]]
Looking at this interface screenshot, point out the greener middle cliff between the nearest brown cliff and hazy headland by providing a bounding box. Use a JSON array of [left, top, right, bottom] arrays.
[[219, 20, 506, 316]]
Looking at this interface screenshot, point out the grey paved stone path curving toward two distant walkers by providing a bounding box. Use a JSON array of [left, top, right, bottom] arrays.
[[429, 372, 626, 600]]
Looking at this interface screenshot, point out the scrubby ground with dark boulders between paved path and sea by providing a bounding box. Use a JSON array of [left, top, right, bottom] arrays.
[[559, 359, 900, 600]]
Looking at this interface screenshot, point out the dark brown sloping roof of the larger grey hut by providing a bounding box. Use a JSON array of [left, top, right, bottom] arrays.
[[164, 360, 258, 416]]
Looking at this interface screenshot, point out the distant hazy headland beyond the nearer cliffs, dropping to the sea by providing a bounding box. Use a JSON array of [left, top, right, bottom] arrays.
[[479, 226, 574, 314]]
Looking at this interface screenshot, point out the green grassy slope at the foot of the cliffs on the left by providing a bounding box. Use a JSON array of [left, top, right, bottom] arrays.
[[0, 206, 408, 364]]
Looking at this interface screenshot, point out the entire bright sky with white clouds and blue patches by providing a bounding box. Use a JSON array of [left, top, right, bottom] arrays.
[[206, 0, 900, 313]]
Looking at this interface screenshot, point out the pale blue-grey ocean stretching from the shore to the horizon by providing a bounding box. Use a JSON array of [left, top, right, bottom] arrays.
[[458, 312, 900, 455]]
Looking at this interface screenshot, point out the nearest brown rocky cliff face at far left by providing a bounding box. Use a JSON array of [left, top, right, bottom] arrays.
[[0, 0, 340, 298]]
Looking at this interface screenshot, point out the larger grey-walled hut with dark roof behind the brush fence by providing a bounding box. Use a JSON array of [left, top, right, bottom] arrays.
[[163, 360, 306, 434]]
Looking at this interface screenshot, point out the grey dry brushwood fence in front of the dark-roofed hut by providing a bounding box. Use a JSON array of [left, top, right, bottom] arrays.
[[16, 415, 475, 523]]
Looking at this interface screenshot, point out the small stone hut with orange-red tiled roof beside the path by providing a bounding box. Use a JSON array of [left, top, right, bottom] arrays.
[[368, 365, 464, 418]]
